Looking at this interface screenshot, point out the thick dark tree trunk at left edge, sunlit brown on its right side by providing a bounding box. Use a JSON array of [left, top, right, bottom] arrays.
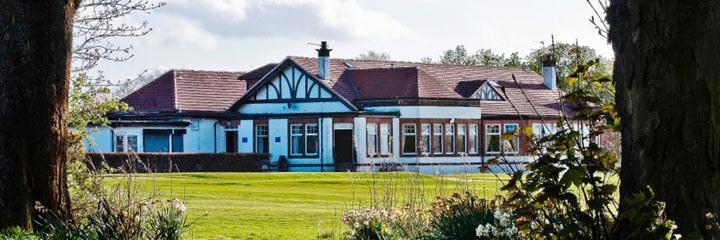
[[0, 0, 75, 229]]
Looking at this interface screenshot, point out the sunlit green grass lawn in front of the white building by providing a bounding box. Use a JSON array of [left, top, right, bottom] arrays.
[[108, 173, 502, 239]]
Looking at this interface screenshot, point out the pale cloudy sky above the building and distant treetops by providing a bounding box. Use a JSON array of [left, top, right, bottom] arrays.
[[91, 0, 612, 81]]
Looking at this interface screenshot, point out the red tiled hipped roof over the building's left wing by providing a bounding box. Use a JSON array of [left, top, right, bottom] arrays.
[[122, 70, 246, 112]]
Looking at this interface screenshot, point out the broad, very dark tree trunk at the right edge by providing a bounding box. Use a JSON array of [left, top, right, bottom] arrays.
[[607, 0, 720, 239]]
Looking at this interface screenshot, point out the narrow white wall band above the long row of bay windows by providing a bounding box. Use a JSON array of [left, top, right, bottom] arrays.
[[365, 106, 480, 119]]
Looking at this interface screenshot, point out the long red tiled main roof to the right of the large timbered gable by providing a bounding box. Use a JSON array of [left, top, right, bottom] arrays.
[[288, 56, 561, 116]]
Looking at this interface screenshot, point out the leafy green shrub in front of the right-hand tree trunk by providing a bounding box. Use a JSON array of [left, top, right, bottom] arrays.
[[490, 57, 676, 239]]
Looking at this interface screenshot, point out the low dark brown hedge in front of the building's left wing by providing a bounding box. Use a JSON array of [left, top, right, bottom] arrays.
[[86, 153, 270, 173]]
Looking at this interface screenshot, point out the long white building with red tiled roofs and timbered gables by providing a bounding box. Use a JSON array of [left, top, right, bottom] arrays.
[[88, 42, 562, 172]]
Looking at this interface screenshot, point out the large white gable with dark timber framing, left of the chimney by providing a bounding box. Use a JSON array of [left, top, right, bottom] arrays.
[[231, 60, 355, 114]]
